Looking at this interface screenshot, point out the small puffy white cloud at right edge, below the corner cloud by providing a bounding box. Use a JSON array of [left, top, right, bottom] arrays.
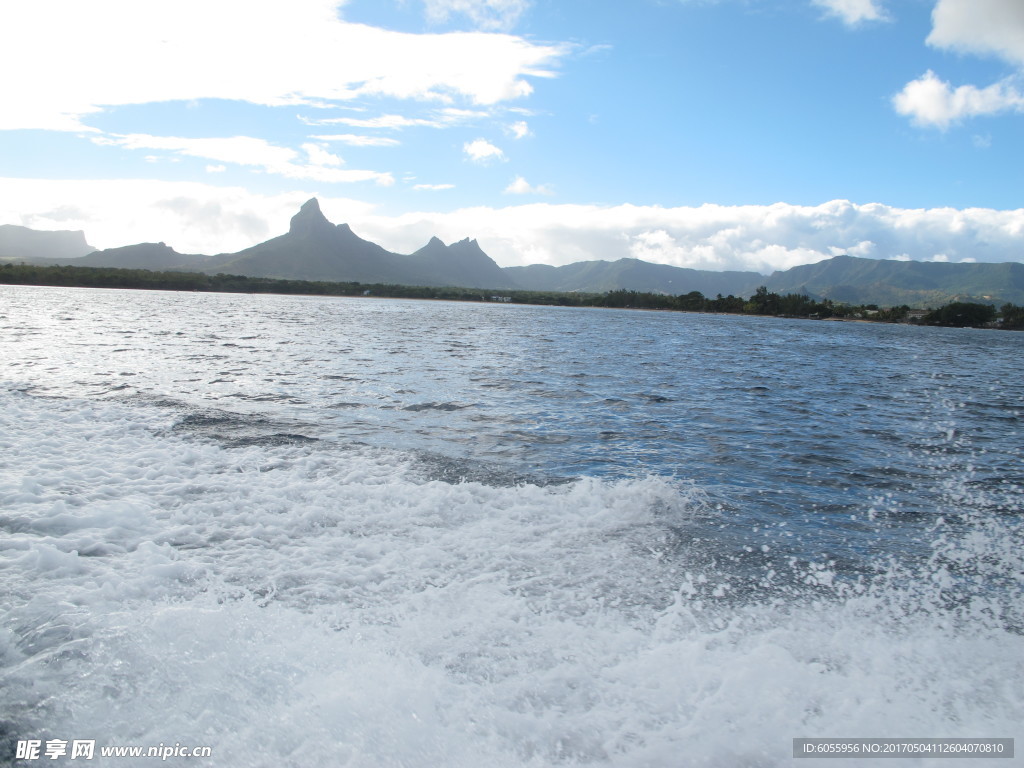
[[893, 71, 1024, 129]]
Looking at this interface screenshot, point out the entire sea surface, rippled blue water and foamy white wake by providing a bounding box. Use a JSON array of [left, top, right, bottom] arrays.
[[0, 287, 1024, 766]]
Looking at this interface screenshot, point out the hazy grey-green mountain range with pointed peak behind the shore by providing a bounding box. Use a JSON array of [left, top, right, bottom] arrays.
[[0, 198, 1024, 307]]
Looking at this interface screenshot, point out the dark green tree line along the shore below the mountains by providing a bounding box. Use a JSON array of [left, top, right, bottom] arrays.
[[0, 263, 1024, 330]]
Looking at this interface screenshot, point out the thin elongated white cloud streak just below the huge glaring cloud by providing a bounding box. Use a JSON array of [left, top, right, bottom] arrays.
[[92, 133, 394, 185]]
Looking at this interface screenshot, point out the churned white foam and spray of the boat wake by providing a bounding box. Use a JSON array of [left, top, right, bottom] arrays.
[[0, 392, 1024, 767]]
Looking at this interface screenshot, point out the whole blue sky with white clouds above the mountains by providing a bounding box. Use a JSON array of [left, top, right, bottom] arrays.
[[0, 0, 1024, 273]]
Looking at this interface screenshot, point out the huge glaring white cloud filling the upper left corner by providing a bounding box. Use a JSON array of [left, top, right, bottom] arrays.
[[0, 0, 568, 131]]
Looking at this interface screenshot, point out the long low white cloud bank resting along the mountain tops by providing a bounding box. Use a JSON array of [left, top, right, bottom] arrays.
[[0, 178, 1024, 272]]
